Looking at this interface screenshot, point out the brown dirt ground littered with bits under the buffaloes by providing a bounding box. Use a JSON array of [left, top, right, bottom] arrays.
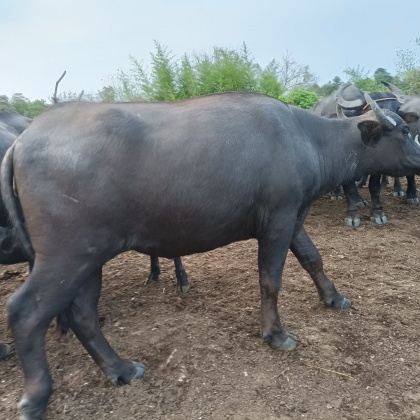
[[0, 185, 420, 420]]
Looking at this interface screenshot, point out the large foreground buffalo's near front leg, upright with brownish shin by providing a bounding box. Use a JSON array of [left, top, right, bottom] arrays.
[[258, 234, 296, 350]]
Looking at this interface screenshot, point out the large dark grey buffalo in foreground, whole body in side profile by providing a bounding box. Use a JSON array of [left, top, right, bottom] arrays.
[[1, 92, 420, 419]]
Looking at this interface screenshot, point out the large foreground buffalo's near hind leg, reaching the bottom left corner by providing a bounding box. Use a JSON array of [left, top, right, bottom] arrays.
[[6, 259, 90, 420]]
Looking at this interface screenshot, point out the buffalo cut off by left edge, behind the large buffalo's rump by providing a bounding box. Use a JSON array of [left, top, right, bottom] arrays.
[[0, 111, 32, 359]]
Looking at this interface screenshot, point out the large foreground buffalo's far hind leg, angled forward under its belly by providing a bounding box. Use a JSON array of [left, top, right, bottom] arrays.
[[66, 268, 144, 385]]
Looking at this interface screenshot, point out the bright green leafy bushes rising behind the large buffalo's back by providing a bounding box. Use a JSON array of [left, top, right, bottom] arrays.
[[107, 41, 318, 101]]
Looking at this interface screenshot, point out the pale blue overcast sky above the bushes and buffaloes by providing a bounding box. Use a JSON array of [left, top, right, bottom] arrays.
[[0, 0, 420, 100]]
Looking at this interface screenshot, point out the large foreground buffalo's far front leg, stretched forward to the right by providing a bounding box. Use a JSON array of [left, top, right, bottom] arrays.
[[290, 227, 351, 309]]
